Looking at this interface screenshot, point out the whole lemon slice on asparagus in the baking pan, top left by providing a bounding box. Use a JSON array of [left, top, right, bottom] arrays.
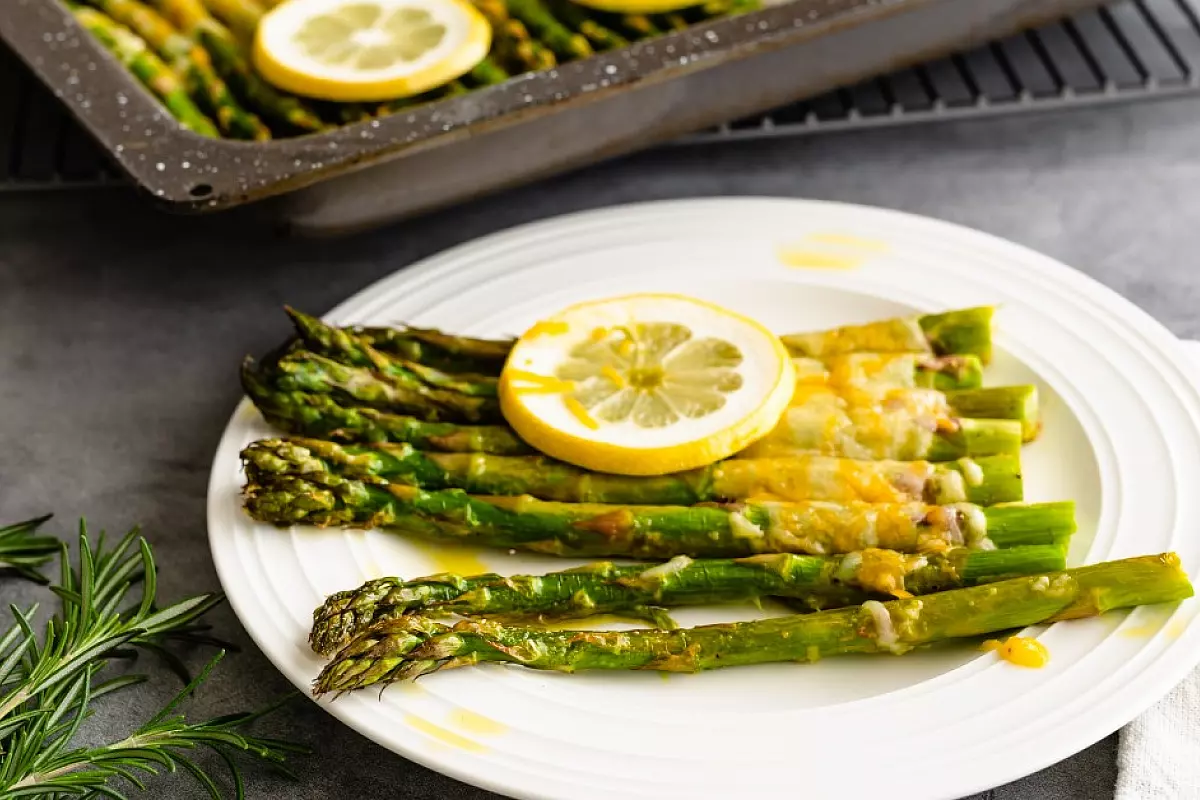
[[254, 0, 492, 102]]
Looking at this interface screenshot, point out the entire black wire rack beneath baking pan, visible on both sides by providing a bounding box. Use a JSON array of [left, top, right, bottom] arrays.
[[0, 0, 1200, 190]]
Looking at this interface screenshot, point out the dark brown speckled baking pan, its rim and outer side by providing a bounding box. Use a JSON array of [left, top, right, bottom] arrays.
[[0, 0, 1099, 233]]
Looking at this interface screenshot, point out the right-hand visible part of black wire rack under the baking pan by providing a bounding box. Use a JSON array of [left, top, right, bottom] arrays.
[[680, 0, 1200, 144]]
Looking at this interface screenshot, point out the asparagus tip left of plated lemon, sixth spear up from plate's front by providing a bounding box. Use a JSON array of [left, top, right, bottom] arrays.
[[271, 350, 503, 422]]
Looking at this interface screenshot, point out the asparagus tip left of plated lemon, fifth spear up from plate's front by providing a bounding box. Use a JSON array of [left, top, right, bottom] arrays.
[[241, 359, 534, 456]]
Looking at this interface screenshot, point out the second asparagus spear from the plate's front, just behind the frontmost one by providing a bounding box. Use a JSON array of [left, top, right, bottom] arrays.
[[308, 545, 1066, 655]]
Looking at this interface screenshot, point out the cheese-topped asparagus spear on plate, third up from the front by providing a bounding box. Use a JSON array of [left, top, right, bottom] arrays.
[[244, 473, 1075, 559]]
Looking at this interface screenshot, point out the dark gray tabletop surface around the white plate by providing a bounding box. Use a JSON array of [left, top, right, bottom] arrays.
[[0, 95, 1200, 800]]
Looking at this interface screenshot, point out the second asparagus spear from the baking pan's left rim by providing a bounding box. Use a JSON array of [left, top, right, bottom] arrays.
[[88, 0, 271, 142]]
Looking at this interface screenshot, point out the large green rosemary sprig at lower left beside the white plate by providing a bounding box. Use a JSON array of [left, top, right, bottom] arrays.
[[0, 523, 304, 799]]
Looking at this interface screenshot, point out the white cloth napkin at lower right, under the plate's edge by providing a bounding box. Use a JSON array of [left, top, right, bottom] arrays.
[[1116, 342, 1200, 800]]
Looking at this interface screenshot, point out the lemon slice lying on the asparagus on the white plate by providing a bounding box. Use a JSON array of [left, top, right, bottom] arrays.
[[499, 294, 796, 475]]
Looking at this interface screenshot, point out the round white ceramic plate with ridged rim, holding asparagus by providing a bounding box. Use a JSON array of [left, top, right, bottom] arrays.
[[209, 199, 1200, 800]]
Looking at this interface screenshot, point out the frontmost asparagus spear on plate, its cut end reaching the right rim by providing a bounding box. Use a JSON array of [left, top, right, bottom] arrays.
[[313, 553, 1193, 694]]
